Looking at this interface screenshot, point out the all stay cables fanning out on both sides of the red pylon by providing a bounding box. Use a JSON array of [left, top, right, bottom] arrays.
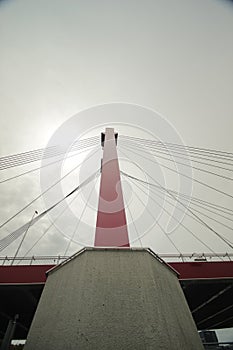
[[0, 135, 233, 263]]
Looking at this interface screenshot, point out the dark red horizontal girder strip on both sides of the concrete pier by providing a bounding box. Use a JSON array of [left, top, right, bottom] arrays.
[[0, 261, 233, 284]]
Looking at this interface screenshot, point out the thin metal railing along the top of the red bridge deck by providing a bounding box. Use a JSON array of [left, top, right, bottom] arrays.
[[0, 253, 233, 266]]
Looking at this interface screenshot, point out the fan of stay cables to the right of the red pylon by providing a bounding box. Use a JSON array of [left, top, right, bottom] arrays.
[[118, 135, 233, 258]]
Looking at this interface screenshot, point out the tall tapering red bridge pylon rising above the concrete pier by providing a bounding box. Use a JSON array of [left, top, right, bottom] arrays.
[[94, 128, 130, 247]]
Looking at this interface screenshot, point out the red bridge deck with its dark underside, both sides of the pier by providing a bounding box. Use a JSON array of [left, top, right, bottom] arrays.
[[0, 262, 233, 339]]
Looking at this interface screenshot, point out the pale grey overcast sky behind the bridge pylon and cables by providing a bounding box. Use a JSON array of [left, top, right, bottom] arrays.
[[0, 0, 233, 342]]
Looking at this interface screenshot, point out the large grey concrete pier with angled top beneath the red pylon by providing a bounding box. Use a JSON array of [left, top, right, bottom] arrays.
[[25, 249, 203, 350]]
